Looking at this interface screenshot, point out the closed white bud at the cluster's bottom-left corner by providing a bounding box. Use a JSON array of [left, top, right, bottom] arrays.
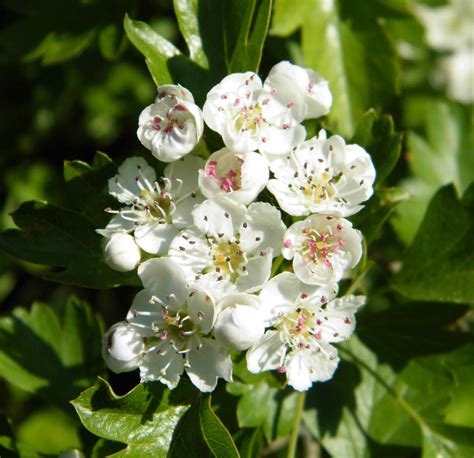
[[102, 321, 145, 374]]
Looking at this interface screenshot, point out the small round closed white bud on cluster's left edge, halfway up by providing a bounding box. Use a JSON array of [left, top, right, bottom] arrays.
[[104, 232, 141, 272]]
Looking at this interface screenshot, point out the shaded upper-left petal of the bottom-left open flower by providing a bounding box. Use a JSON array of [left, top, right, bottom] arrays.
[[138, 258, 188, 305]]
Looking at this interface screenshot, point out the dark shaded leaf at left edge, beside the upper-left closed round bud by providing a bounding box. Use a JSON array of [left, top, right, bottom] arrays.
[[0, 201, 140, 288]]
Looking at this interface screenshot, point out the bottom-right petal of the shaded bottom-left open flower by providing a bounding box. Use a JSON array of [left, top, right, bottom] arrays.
[[186, 339, 232, 393]]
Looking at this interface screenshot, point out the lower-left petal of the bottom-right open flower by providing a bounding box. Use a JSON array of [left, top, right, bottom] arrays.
[[246, 331, 286, 374]]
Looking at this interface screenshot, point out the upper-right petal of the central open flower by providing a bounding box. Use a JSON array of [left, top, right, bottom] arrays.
[[240, 202, 286, 256]]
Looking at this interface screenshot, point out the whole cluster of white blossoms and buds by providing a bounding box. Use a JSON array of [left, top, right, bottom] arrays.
[[98, 62, 375, 392]]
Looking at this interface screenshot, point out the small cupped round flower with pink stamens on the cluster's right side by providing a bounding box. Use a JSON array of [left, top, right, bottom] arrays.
[[282, 215, 362, 285]]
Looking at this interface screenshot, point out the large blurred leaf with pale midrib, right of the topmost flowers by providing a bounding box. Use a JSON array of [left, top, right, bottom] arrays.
[[302, 0, 398, 136]]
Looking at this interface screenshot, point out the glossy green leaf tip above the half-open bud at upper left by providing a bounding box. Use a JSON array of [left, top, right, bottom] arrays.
[[124, 15, 181, 86]]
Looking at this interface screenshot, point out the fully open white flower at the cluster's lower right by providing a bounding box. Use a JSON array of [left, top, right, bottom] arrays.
[[247, 272, 365, 391]]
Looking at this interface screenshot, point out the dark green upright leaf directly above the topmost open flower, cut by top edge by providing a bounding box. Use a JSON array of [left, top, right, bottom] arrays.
[[224, 0, 272, 73]]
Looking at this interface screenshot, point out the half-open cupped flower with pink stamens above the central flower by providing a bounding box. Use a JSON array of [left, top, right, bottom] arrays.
[[199, 148, 269, 205]]
